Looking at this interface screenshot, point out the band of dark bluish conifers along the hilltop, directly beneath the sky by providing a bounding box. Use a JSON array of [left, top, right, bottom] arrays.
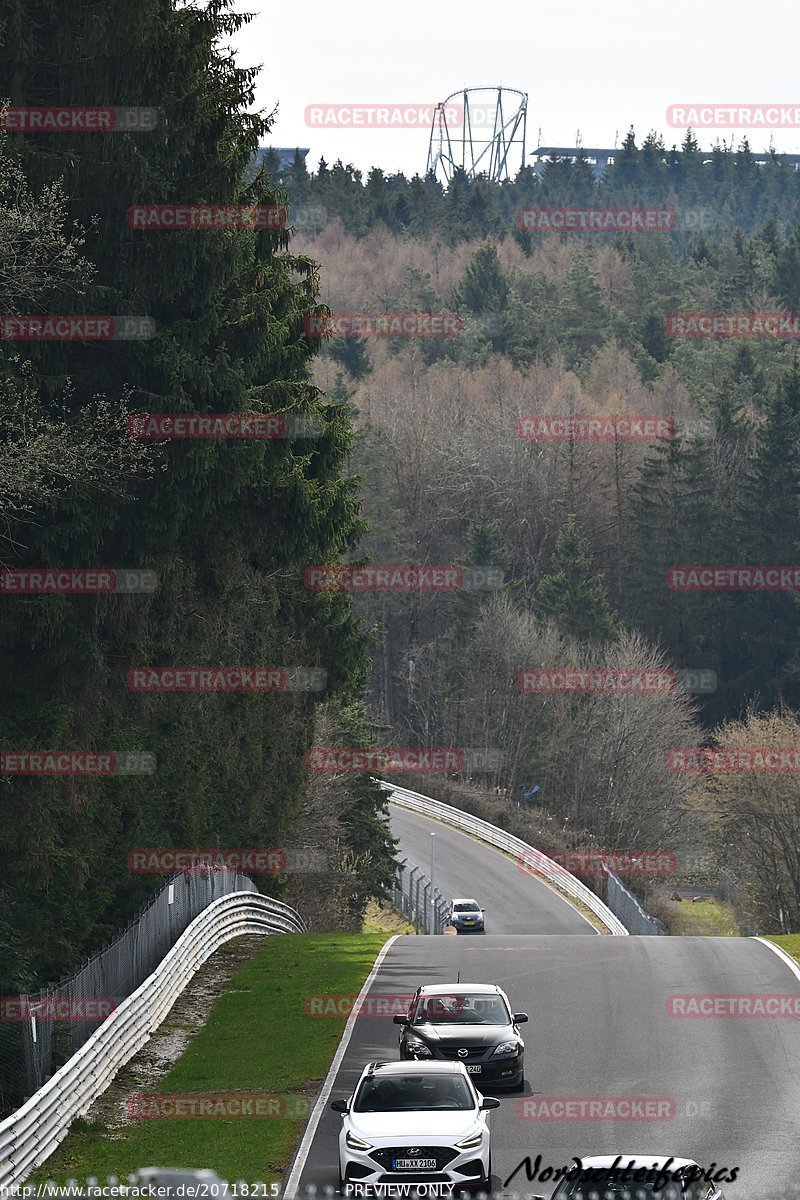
[[262, 128, 800, 244]]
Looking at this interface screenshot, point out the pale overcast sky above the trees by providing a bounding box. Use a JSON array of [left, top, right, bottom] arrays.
[[234, 0, 800, 175]]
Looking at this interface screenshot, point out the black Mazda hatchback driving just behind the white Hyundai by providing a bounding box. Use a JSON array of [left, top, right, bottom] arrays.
[[393, 983, 528, 1092]]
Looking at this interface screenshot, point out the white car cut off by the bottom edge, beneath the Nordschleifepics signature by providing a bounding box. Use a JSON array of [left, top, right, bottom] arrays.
[[542, 1153, 727, 1200]]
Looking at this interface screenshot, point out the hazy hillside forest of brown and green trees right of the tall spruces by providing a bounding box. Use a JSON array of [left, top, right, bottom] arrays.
[[280, 133, 800, 929]]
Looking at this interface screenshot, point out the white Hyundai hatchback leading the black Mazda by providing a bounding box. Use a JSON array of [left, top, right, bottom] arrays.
[[331, 1062, 500, 1193]]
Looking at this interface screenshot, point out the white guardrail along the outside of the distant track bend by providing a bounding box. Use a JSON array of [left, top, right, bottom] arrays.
[[378, 779, 628, 937]]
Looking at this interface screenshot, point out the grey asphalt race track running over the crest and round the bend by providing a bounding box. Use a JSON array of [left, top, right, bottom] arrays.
[[287, 808, 800, 1200]]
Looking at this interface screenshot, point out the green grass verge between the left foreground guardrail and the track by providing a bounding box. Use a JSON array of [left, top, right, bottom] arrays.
[[28, 931, 386, 1184]]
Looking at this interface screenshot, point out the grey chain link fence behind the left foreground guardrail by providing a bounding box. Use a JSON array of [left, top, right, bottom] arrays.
[[0, 866, 258, 1111]]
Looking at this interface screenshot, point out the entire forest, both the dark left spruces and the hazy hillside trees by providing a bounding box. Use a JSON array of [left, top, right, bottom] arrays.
[[0, 0, 800, 1113]]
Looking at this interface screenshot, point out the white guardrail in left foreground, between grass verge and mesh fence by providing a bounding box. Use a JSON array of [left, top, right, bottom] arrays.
[[0, 892, 306, 1193]]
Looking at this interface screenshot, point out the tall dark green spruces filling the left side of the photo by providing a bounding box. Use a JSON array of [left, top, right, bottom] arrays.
[[0, 0, 383, 989]]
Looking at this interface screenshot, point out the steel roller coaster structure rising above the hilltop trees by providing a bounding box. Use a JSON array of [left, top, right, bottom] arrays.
[[427, 88, 528, 184]]
